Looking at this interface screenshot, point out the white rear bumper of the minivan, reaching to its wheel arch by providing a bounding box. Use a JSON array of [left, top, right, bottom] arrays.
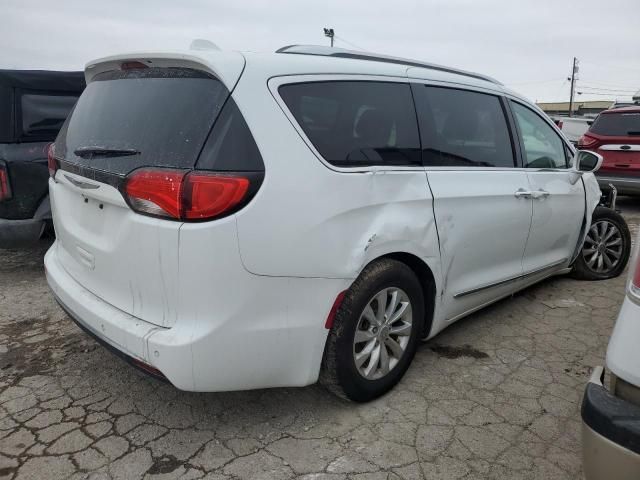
[[45, 242, 345, 391]]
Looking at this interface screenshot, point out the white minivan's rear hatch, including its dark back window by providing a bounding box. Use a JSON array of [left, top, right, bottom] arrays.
[[50, 61, 240, 327]]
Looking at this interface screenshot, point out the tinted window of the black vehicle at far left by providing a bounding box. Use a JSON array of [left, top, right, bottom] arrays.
[[18, 93, 78, 140]]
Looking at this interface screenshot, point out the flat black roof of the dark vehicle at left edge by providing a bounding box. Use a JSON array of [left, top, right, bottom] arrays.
[[0, 70, 85, 93]]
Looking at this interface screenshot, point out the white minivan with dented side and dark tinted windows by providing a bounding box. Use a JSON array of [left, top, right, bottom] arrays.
[[45, 46, 630, 401]]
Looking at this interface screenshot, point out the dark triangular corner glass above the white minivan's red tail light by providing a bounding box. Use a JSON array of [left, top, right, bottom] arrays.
[[198, 98, 264, 171]]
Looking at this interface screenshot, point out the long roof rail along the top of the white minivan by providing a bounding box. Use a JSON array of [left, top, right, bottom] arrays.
[[276, 45, 502, 85]]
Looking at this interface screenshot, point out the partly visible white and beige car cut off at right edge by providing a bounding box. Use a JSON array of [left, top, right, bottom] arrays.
[[582, 231, 640, 480]]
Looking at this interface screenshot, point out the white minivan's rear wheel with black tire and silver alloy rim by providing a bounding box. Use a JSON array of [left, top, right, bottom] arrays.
[[320, 259, 424, 402]]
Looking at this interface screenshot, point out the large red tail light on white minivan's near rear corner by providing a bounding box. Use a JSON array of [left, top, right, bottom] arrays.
[[124, 169, 251, 221]]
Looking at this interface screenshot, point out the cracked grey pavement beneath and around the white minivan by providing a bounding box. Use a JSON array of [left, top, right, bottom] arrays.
[[0, 199, 640, 480]]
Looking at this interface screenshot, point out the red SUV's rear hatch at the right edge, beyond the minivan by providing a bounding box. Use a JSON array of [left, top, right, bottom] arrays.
[[580, 110, 640, 176]]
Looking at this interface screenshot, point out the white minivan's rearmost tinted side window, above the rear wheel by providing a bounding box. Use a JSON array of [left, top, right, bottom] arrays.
[[280, 81, 421, 167]]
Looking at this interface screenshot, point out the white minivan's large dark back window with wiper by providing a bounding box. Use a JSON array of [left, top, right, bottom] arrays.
[[56, 68, 229, 175]]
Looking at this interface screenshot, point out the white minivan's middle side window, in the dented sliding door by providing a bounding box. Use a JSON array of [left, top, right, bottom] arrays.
[[416, 85, 515, 168]]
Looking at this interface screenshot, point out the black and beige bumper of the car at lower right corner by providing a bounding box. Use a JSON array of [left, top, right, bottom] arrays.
[[581, 367, 640, 480]]
